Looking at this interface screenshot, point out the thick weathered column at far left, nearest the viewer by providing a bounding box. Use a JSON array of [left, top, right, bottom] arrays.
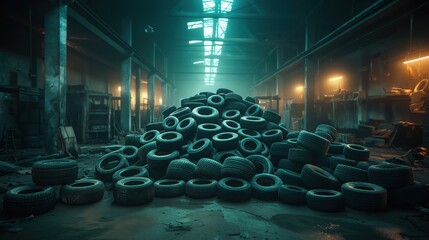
[[44, 4, 67, 154]]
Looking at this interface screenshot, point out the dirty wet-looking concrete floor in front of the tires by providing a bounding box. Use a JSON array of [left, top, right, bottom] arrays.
[[0, 146, 429, 240]]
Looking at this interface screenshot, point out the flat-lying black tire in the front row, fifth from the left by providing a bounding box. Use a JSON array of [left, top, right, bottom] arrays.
[[185, 178, 217, 199]]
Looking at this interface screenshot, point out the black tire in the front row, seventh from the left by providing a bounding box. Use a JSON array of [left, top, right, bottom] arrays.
[[250, 173, 283, 200]]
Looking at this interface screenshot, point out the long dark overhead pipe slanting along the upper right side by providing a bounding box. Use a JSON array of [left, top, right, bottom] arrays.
[[254, 0, 408, 88]]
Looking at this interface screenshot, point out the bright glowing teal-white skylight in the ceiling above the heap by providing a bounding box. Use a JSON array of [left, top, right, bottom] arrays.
[[188, 0, 234, 85]]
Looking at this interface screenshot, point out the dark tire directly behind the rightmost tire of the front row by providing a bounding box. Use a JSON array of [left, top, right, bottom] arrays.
[[368, 164, 414, 190]]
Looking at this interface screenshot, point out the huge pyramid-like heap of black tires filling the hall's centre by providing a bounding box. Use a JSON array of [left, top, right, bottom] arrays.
[[5, 88, 428, 217]]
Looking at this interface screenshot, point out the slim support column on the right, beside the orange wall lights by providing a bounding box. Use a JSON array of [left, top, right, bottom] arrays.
[[304, 23, 317, 131]]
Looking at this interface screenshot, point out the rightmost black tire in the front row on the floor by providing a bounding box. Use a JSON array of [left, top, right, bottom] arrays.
[[341, 182, 387, 212]]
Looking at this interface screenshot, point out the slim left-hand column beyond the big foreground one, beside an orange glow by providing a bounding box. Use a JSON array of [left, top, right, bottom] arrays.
[[121, 18, 132, 132]]
